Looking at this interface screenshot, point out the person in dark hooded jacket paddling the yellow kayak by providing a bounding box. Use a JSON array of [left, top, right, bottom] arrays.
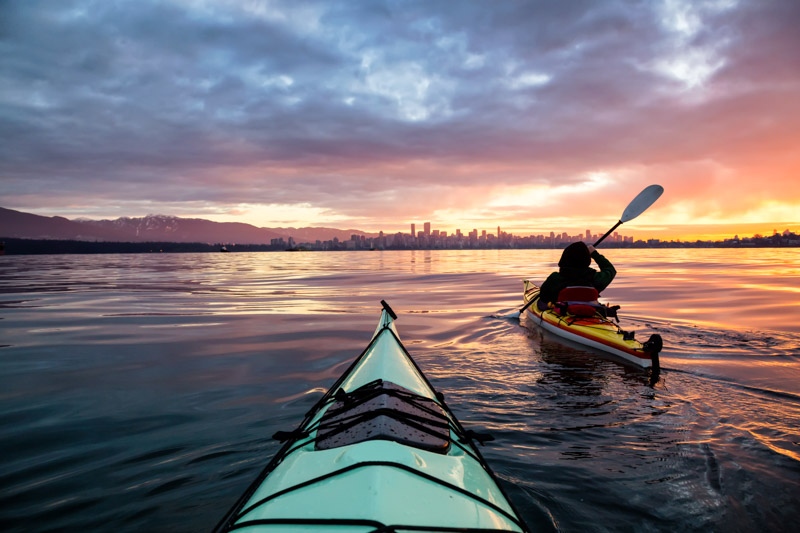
[[537, 241, 617, 310]]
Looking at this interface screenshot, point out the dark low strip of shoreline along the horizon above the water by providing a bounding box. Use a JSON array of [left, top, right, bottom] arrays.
[[0, 235, 800, 255]]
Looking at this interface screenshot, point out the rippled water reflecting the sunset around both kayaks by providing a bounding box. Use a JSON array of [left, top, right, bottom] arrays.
[[0, 249, 800, 531]]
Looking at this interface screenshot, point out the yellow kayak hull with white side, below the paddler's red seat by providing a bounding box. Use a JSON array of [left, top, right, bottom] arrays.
[[523, 280, 661, 374]]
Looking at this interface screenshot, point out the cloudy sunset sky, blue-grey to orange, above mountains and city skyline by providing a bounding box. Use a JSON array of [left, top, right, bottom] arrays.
[[0, 0, 800, 239]]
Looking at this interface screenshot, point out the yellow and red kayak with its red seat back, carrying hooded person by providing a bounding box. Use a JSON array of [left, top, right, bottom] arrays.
[[523, 280, 662, 381]]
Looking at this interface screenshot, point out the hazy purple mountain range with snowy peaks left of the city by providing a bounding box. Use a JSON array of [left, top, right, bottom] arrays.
[[0, 207, 376, 244]]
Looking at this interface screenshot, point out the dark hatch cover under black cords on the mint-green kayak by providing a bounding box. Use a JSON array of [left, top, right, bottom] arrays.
[[315, 380, 450, 454]]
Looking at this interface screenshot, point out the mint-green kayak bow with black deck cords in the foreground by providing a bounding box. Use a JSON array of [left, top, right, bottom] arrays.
[[212, 302, 528, 533]]
